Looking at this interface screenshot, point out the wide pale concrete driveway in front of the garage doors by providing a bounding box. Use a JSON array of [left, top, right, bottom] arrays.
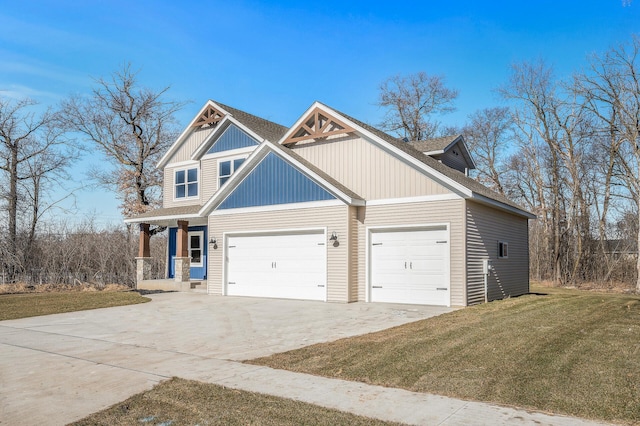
[[0, 293, 451, 425]]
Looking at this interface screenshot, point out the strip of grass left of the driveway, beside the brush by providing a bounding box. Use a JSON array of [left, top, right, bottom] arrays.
[[0, 291, 151, 321]]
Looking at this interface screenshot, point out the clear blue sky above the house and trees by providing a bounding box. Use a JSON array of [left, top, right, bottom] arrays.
[[0, 0, 640, 228]]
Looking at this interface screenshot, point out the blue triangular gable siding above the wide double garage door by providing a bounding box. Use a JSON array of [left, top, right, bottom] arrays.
[[216, 152, 336, 210]]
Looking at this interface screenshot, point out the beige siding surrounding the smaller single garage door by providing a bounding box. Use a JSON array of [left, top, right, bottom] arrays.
[[355, 198, 466, 306]]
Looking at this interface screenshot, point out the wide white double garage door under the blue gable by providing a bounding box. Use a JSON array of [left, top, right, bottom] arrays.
[[226, 231, 327, 300]]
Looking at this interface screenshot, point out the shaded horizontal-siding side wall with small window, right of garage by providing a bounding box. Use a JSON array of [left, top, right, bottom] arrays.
[[466, 201, 529, 305]]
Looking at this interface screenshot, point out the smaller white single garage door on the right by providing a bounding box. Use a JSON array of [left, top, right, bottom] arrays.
[[370, 226, 450, 306]]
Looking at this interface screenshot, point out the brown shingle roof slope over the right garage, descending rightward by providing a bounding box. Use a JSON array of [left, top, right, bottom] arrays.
[[328, 107, 527, 212]]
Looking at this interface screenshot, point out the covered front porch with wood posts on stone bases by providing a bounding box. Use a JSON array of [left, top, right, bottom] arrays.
[[125, 206, 209, 293]]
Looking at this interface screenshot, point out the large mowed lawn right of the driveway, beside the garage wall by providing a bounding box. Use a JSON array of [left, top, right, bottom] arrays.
[[248, 288, 640, 423]]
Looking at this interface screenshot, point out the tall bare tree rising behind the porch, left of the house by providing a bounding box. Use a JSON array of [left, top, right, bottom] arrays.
[[63, 64, 185, 216]]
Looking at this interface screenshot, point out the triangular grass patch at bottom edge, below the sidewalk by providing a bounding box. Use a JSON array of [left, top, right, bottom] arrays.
[[72, 378, 397, 426]]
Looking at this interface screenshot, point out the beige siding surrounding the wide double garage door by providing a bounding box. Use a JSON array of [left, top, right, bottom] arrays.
[[207, 205, 350, 302]]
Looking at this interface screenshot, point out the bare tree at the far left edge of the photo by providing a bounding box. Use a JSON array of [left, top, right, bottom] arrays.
[[0, 97, 73, 272]]
